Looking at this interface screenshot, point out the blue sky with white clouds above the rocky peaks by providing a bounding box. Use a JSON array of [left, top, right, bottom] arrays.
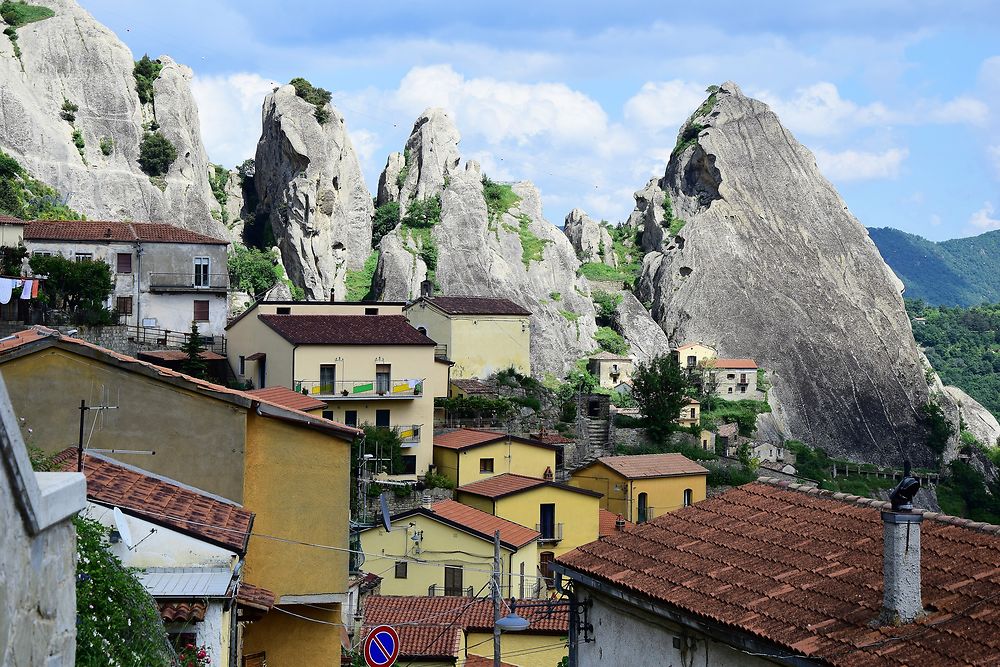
[[81, 0, 1000, 240]]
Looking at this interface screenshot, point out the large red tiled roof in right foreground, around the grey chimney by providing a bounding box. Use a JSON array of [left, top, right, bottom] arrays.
[[557, 481, 1000, 667]]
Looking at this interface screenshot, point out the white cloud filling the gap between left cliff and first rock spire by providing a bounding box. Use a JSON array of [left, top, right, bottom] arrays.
[[191, 72, 278, 167]]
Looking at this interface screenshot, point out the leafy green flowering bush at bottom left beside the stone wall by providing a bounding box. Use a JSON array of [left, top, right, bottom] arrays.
[[73, 517, 175, 667]]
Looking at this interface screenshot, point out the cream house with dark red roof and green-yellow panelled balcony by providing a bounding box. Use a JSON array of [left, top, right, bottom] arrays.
[[227, 302, 450, 480]]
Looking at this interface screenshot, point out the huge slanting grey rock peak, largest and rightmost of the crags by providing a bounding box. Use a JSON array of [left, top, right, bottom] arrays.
[[632, 83, 957, 465]]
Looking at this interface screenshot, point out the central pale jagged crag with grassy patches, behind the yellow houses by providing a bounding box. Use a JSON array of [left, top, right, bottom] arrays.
[[373, 109, 596, 377]]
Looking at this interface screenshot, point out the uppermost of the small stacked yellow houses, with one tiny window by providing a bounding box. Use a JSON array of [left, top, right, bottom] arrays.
[[434, 428, 562, 487]]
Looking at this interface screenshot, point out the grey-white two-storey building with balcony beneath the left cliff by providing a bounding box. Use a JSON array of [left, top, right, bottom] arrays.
[[23, 220, 229, 343]]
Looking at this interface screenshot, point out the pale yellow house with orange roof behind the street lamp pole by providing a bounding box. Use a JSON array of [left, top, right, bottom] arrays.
[[361, 500, 539, 598]]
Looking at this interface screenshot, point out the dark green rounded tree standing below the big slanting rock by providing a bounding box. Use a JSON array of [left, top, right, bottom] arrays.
[[632, 354, 688, 440]]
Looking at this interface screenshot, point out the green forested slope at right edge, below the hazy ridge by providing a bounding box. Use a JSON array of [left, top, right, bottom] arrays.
[[906, 300, 1000, 420]]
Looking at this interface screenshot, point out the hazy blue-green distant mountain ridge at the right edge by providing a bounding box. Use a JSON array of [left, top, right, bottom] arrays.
[[868, 227, 1000, 306]]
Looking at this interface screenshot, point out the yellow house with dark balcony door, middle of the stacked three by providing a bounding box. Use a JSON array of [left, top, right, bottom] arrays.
[[456, 473, 601, 576]]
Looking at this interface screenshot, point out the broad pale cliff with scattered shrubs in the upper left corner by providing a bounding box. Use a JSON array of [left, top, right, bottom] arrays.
[[0, 0, 227, 238]]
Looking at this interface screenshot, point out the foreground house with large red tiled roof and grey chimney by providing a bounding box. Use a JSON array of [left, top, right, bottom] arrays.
[[553, 480, 1000, 667]]
